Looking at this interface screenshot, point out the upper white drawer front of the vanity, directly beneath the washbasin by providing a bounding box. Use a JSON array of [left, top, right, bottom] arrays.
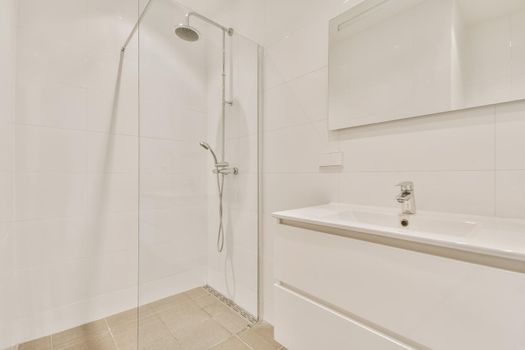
[[274, 225, 525, 350]]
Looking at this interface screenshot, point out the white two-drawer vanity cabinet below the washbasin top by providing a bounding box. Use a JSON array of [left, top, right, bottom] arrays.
[[274, 221, 525, 350]]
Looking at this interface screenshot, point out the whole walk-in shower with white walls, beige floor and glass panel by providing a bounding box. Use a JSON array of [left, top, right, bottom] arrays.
[[0, 0, 262, 350]]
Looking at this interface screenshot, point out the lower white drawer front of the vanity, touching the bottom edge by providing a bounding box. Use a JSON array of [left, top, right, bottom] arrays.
[[274, 284, 411, 350]]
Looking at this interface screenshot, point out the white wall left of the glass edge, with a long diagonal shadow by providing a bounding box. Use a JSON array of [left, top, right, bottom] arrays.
[[8, 0, 138, 341]]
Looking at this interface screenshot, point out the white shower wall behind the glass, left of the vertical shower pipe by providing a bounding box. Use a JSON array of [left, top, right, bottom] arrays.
[[139, 0, 211, 303]]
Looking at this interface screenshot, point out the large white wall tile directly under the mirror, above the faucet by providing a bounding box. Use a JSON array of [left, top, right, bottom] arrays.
[[339, 107, 494, 171]]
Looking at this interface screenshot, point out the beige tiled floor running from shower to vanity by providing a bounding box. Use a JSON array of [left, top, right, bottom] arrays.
[[18, 288, 284, 350]]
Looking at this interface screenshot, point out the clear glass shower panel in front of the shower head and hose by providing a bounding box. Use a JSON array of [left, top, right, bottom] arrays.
[[138, 0, 260, 348]]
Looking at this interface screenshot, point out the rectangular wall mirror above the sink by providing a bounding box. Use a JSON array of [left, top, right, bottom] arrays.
[[328, 0, 525, 130]]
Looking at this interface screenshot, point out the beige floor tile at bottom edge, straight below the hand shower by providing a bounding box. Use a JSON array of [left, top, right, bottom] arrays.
[[174, 319, 232, 350]]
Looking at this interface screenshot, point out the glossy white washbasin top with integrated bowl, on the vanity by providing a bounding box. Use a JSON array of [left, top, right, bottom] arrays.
[[273, 203, 525, 272]]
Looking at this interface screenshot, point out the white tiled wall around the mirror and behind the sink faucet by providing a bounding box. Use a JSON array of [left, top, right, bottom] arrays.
[[263, 0, 525, 321]]
